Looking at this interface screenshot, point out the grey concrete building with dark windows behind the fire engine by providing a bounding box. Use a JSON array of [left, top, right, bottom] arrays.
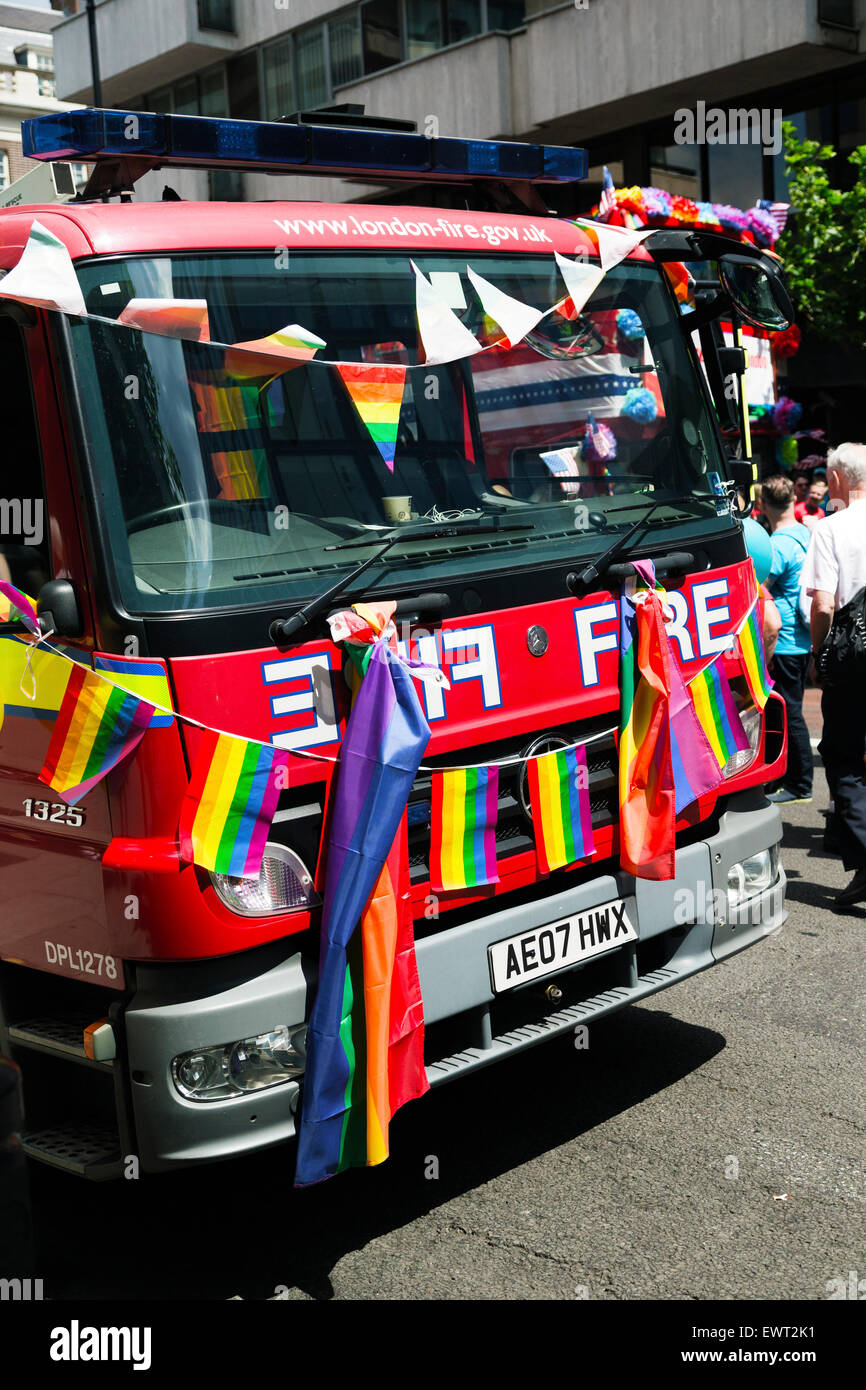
[[45, 0, 866, 436]]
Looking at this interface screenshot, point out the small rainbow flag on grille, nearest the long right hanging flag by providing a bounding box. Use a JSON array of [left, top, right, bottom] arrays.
[[527, 748, 595, 873]]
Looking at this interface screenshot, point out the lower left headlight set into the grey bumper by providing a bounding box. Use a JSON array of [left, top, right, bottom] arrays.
[[171, 1023, 307, 1101]]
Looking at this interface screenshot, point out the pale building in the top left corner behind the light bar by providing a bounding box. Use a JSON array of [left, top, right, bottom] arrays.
[[0, 4, 85, 189]]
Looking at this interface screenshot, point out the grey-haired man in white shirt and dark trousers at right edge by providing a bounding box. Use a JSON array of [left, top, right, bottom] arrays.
[[801, 443, 866, 908]]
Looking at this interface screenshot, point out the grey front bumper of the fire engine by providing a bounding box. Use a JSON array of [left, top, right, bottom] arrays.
[[125, 790, 787, 1170]]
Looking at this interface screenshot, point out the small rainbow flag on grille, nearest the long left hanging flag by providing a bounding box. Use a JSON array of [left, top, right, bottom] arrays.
[[430, 767, 499, 892]]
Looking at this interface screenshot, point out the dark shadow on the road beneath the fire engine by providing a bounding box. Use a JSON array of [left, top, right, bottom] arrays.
[[27, 1006, 726, 1300]]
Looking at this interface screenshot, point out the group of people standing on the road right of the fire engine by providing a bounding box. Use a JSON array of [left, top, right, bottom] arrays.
[[758, 443, 866, 909]]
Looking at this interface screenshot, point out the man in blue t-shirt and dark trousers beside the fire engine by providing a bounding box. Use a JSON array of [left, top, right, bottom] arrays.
[[760, 474, 813, 803]]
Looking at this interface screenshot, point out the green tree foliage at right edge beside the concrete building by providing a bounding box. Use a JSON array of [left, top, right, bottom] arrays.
[[776, 121, 866, 348]]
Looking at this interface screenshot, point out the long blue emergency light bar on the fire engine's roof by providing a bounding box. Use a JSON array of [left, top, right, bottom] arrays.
[[21, 107, 589, 183]]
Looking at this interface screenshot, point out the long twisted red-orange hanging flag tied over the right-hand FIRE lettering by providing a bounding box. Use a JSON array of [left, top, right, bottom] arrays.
[[620, 560, 676, 878]]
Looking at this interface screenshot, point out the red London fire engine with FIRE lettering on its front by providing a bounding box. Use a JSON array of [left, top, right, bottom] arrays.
[[0, 110, 788, 1179]]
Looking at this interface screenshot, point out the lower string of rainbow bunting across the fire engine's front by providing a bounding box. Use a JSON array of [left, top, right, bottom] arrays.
[[0, 566, 771, 891]]
